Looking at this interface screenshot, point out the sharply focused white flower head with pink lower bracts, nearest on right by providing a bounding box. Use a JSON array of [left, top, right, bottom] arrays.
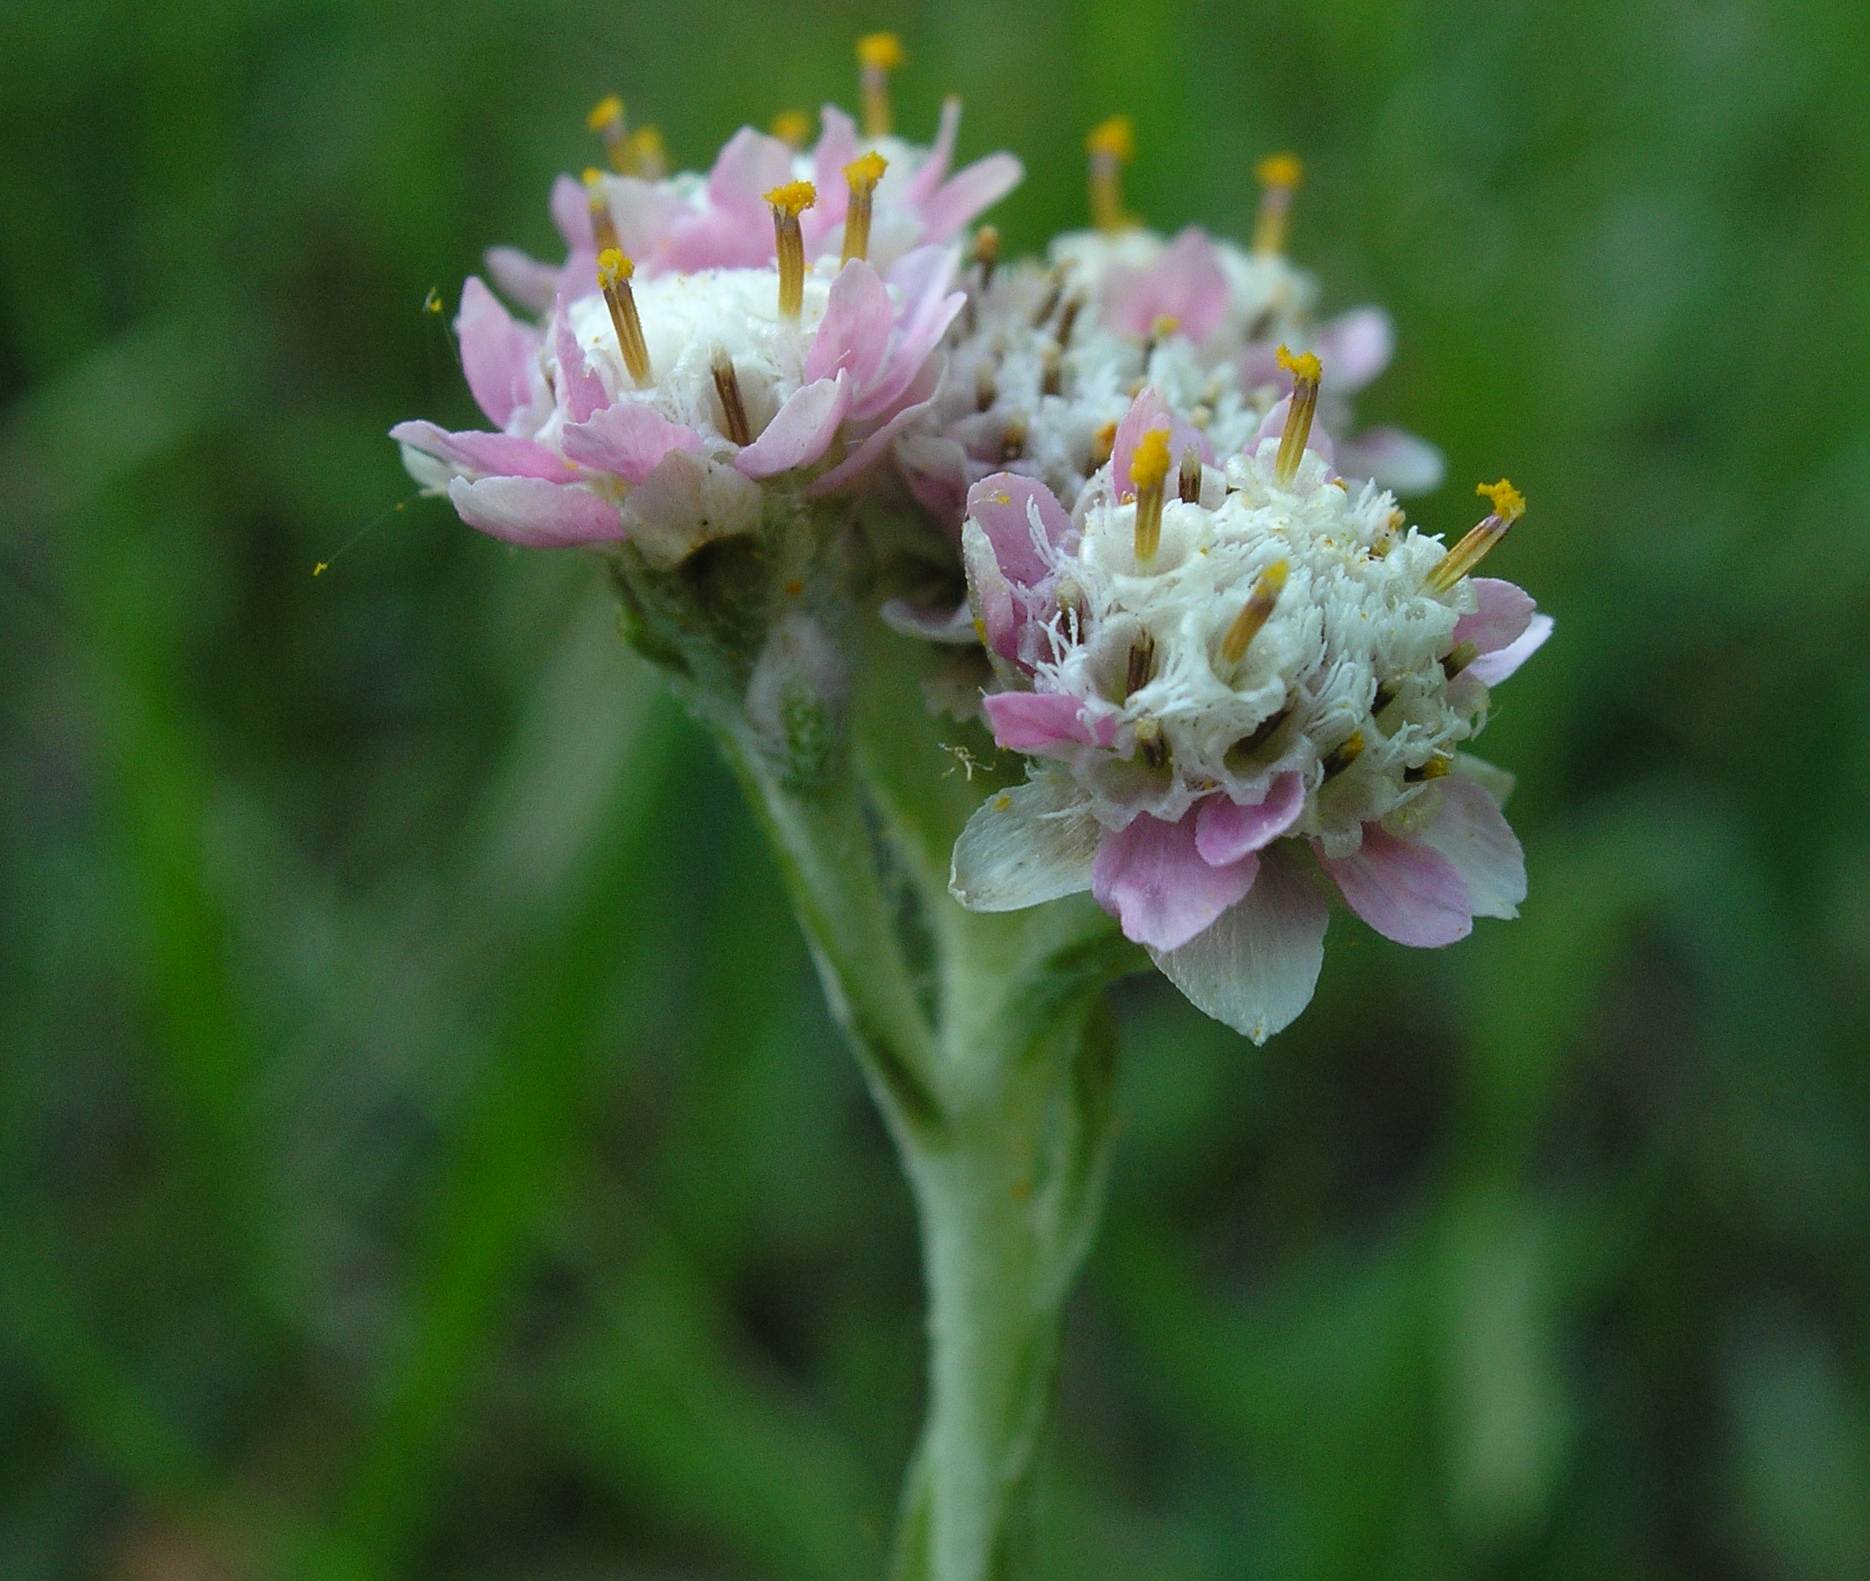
[[954, 385, 1550, 1038]]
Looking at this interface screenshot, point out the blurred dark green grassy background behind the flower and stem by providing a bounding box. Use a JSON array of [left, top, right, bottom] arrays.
[[0, 0, 1870, 1581]]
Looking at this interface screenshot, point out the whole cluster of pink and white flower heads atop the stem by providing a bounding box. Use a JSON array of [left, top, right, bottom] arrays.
[[393, 36, 1552, 1040]]
